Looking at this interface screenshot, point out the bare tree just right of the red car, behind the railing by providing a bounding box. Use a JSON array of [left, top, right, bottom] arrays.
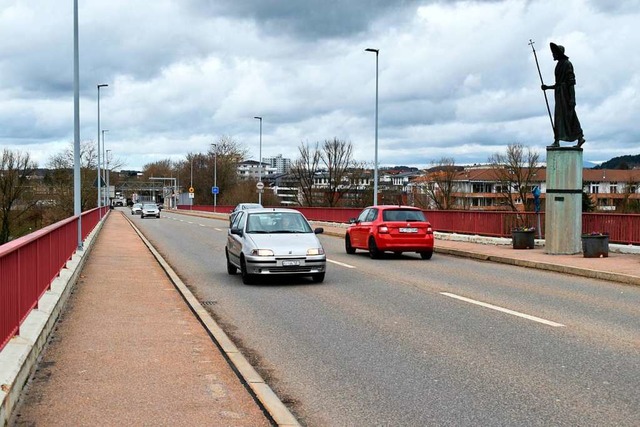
[[424, 157, 461, 210]]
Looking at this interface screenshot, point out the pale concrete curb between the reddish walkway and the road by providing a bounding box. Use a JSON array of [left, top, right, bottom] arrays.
[[123, 214, 300, 427]]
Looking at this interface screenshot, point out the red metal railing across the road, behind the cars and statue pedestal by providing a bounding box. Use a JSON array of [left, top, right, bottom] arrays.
[[178, 205, 640, 245]]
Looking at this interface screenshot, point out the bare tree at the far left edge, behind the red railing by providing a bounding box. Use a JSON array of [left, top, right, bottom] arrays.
[[0, 148, 36, 244]]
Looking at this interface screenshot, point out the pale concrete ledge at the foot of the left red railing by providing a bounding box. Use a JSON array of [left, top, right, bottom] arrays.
[[0, 213, 109, 426]]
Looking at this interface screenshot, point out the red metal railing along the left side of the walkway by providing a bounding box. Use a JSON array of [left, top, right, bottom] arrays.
[[0, 207, 108, 350]]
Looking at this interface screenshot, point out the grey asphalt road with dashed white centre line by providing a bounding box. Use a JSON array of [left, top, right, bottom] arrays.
[[127, 212, 640, 426]]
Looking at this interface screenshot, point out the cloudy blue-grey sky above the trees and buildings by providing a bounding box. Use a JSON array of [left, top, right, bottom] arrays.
[[0, 0, 640, 169]]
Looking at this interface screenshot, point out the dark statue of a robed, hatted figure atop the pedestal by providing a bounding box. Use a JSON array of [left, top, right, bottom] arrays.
[[542, 43, 585, 147]]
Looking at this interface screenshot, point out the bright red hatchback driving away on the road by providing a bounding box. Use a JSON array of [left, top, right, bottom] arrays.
[[344, 205, 433, 259]]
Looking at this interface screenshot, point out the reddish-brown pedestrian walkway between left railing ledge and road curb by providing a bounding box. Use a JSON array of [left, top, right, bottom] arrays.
[[12, 211, 271, 426]]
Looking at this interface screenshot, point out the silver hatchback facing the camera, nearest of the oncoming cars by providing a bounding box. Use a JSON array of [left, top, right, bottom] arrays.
[[225, 208, 327, 284]]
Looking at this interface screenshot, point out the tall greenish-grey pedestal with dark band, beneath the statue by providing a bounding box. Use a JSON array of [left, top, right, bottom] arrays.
[[545, 147, 582, 255]]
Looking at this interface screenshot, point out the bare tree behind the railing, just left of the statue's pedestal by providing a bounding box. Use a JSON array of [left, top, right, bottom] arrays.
[[489, 144, 541, 212]]
